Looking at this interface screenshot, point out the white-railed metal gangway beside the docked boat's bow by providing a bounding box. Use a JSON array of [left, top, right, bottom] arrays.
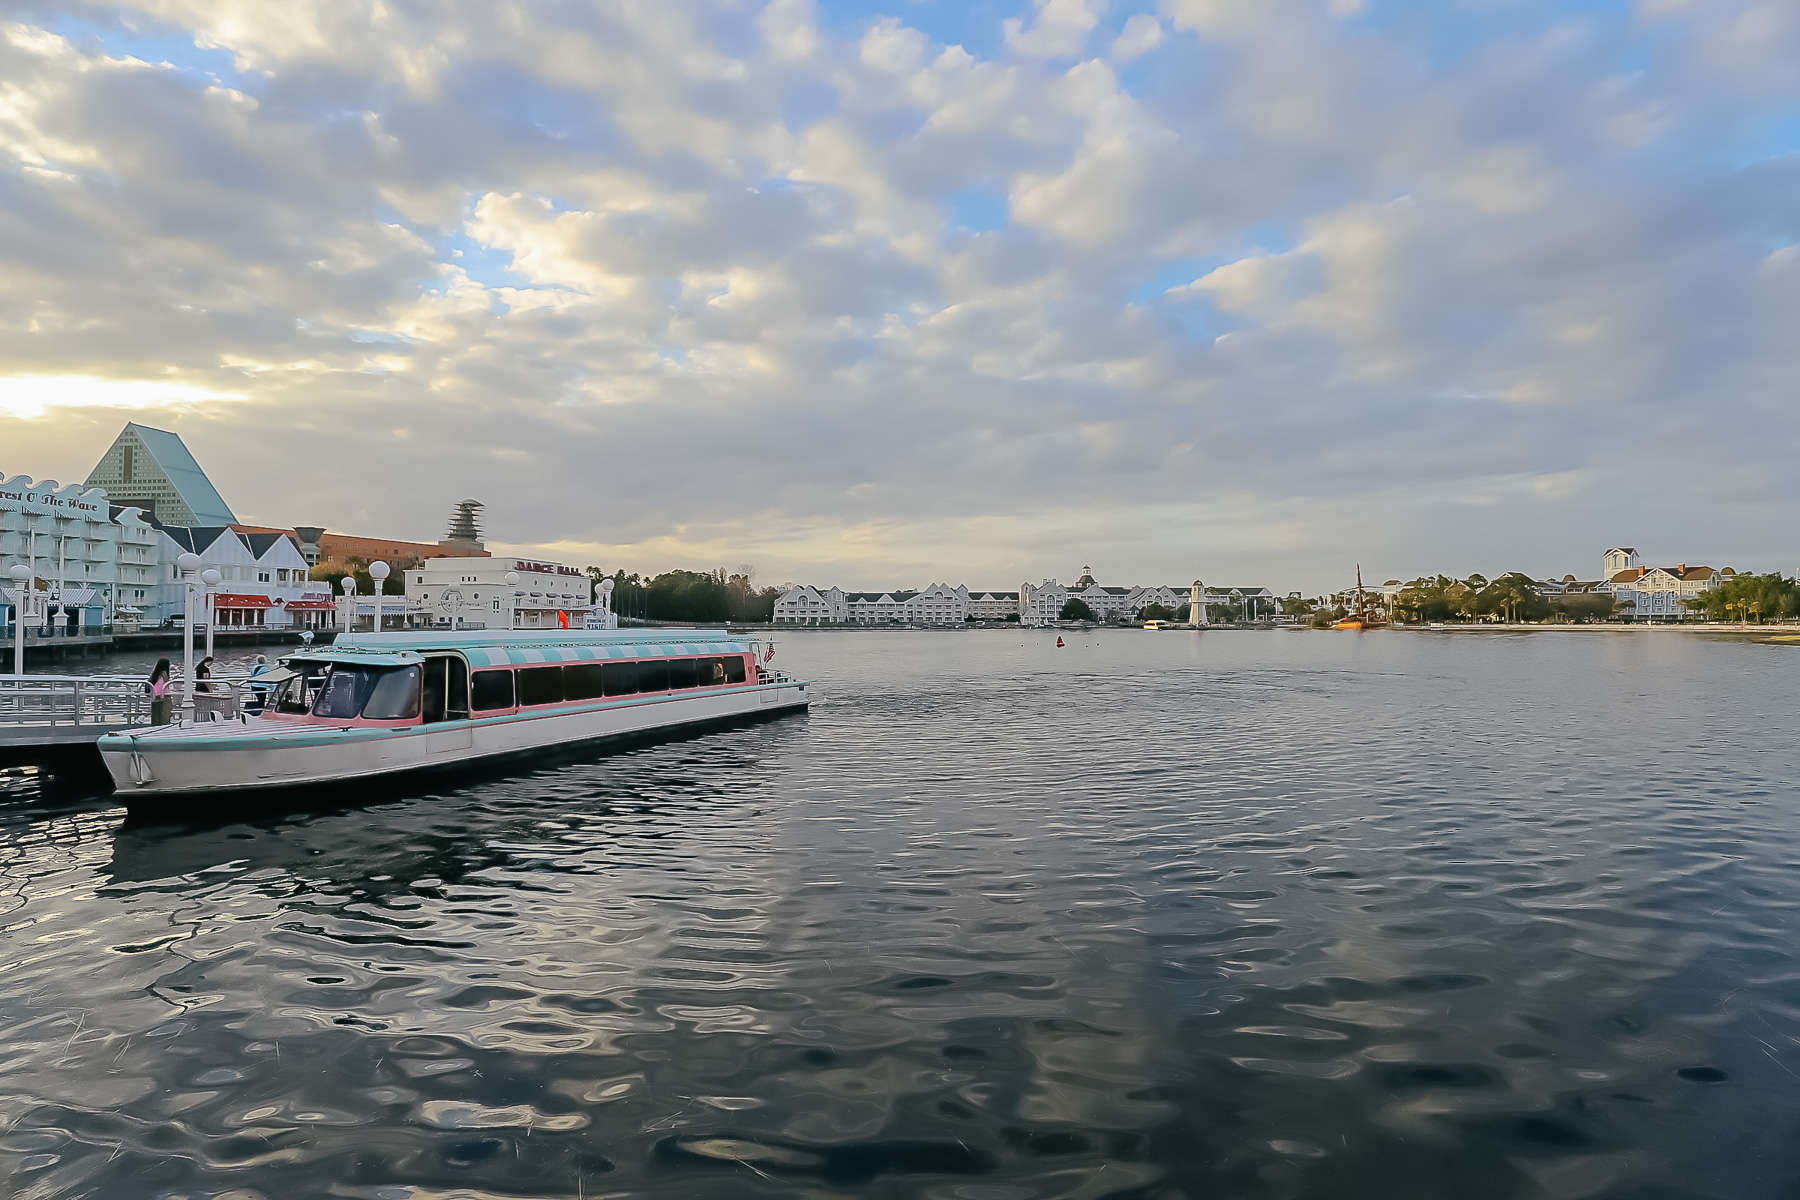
[[0, 675, 255, 750]]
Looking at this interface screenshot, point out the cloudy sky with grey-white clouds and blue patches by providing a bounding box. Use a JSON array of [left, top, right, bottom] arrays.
[[0, 0, 1800, 590]]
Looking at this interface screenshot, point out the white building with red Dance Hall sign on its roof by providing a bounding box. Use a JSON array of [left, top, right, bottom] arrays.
[[405, 556, 594, 630]]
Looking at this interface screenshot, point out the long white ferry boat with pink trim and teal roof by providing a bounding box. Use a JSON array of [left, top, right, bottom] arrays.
[[99, 630, 808, 799]]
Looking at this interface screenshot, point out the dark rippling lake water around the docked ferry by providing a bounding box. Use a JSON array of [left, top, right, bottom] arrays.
[[0, 631, 1800, 1200]]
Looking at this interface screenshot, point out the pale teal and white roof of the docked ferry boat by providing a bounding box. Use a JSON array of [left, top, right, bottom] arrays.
[[316, 630, 752, 667]]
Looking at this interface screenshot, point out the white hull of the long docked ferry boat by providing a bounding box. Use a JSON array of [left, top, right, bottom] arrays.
[[99, 682, 808, 801]]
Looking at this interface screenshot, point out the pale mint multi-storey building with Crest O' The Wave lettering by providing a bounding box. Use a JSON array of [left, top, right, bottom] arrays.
[[0, 471, 160, 628]]
